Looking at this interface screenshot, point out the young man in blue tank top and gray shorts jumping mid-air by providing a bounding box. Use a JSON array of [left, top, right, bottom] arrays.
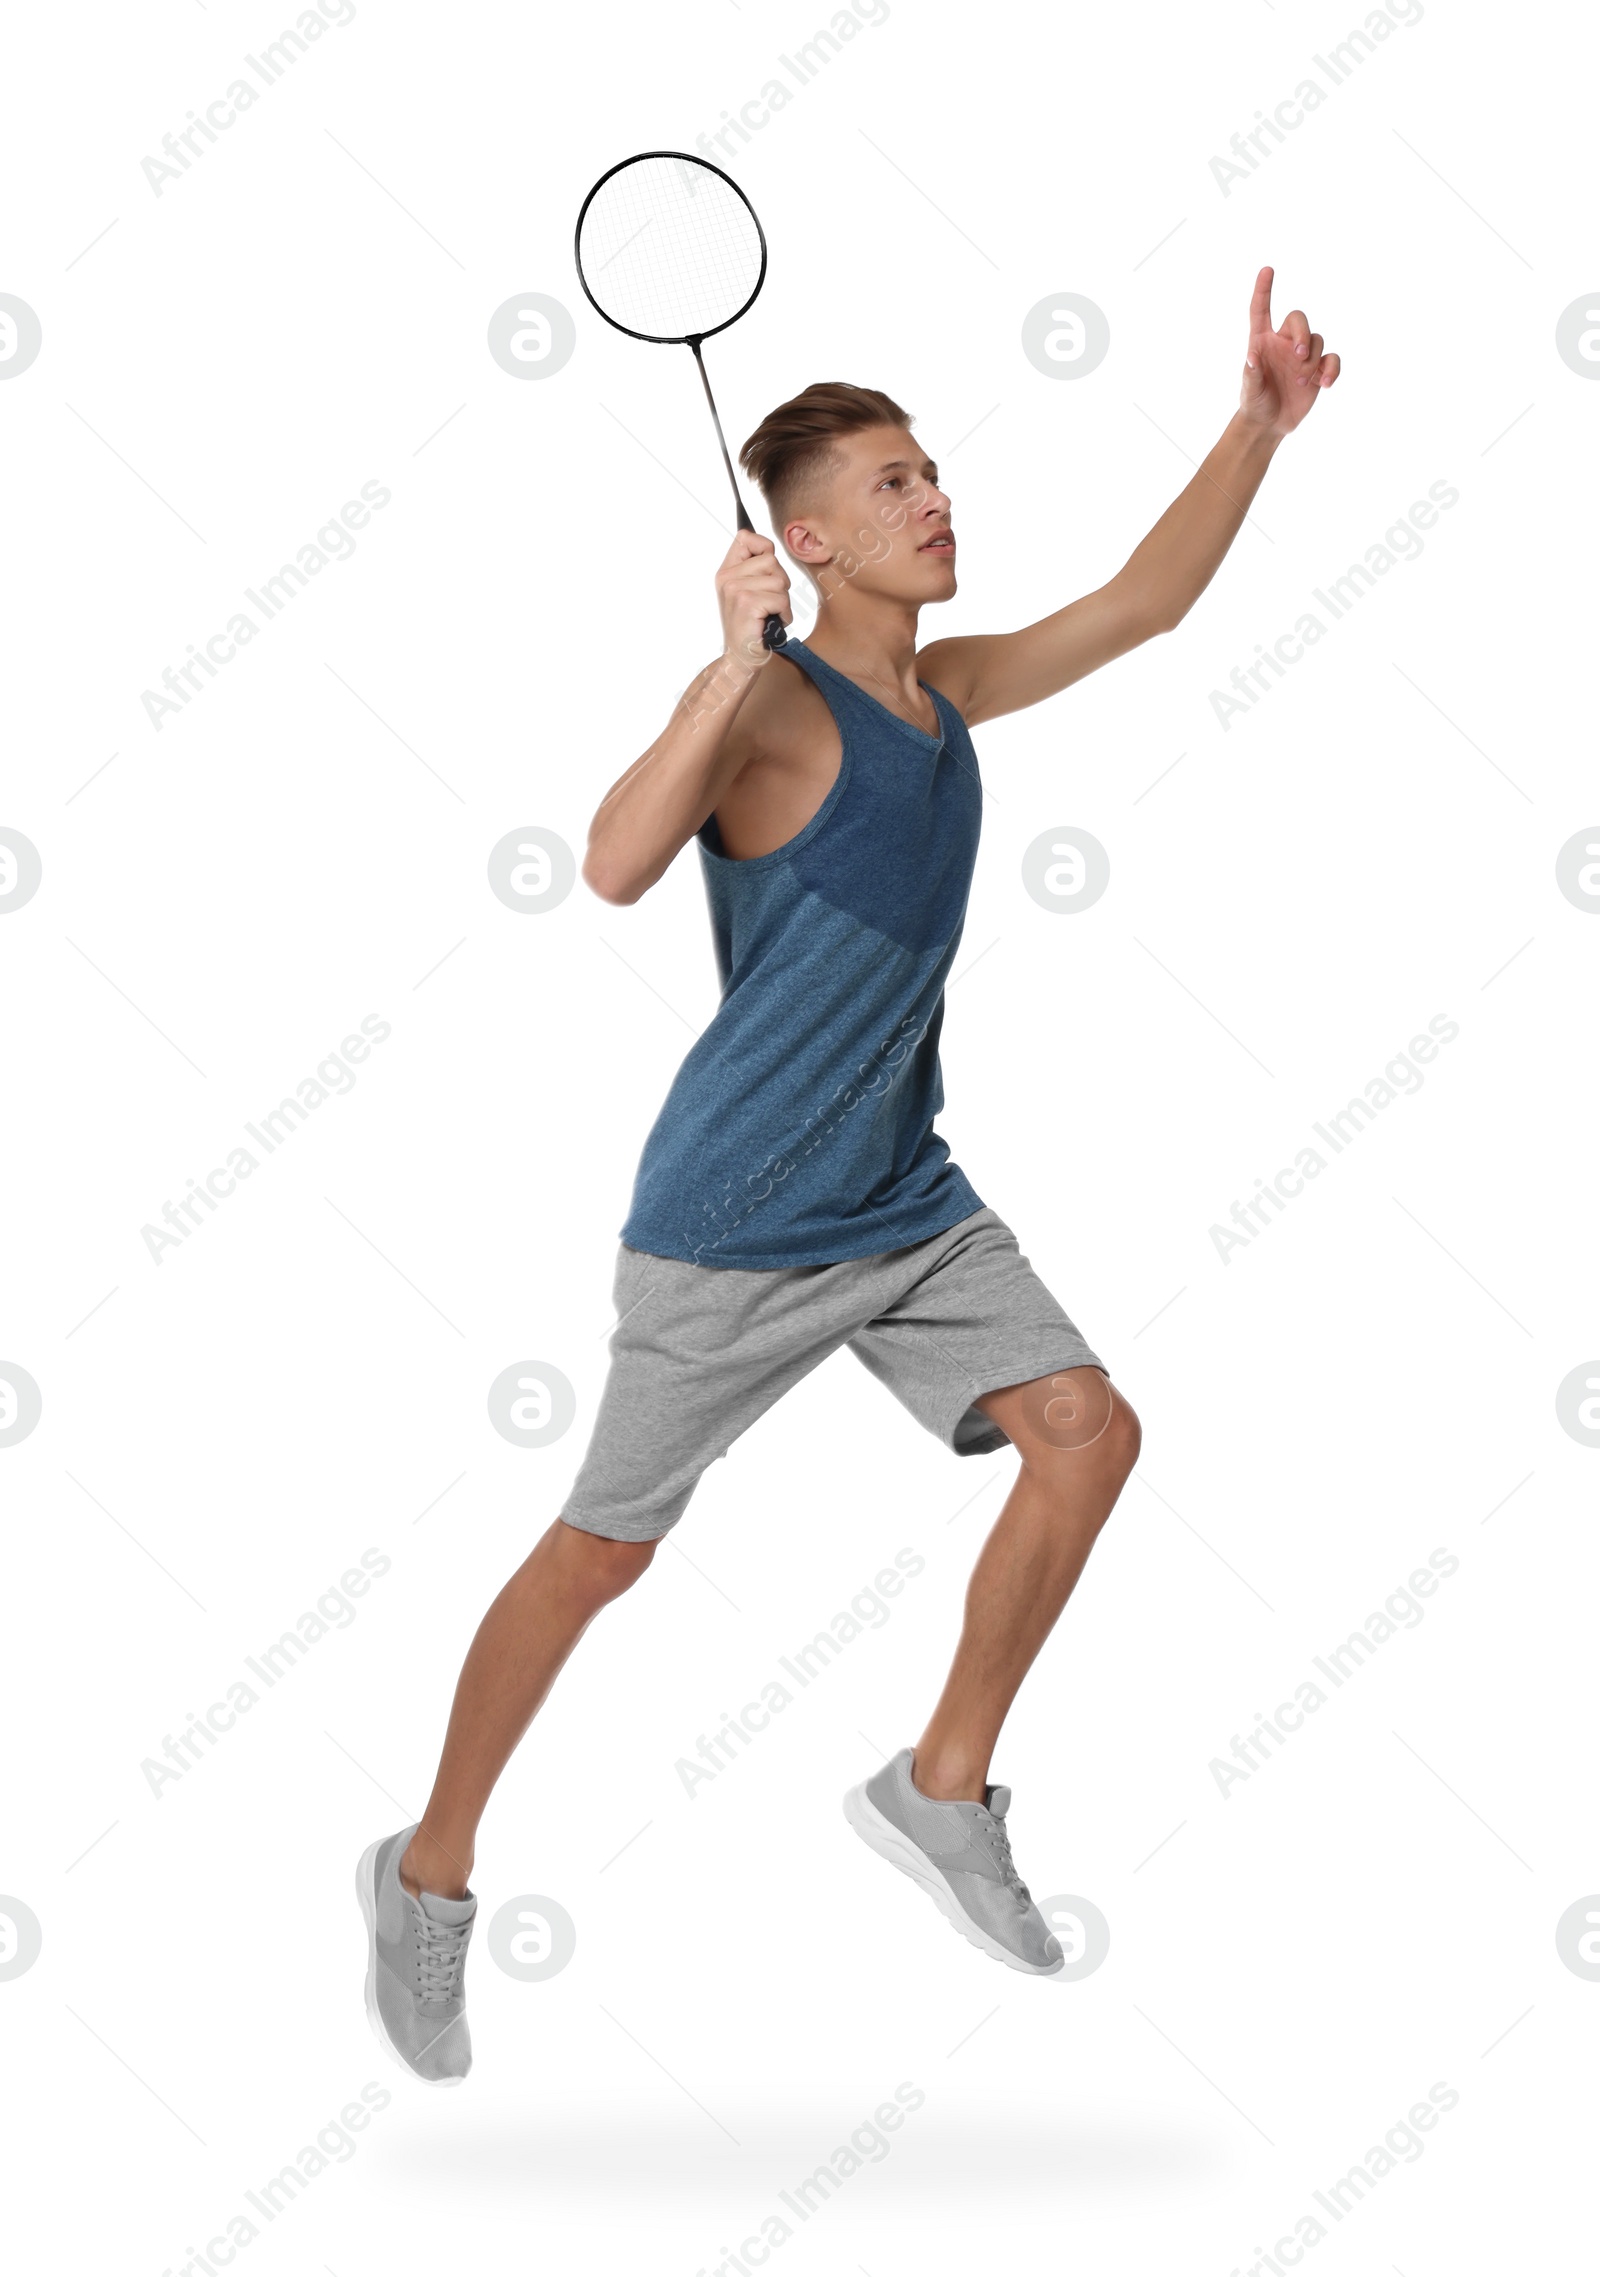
[[357, 269, 1338, 2083]]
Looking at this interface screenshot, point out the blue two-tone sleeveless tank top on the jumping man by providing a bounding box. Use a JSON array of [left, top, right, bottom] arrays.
[[621, 640, 983, 1266]]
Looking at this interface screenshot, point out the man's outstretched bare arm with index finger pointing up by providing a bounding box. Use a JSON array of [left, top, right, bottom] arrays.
[[917, 269, 1338, 724]]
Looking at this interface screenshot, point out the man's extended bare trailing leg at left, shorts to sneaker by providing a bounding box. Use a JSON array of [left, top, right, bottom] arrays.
[[401, 1519, 655, 1897]]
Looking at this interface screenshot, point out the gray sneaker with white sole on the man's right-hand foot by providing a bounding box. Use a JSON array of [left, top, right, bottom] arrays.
[[844, 1746, 1065, 1976]]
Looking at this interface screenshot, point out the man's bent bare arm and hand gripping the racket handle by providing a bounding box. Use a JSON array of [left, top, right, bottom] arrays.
[[583, 531, 792, 902]]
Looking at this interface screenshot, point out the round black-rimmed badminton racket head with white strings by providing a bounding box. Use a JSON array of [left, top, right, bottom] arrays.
[[574, 150, 767, 346]]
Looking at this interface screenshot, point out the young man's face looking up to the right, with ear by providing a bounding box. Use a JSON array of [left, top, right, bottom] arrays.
[[783, 426, 956, 608]]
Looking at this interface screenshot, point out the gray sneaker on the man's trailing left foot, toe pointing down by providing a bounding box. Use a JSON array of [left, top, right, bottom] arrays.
[[355, 1826, 478, 2088]]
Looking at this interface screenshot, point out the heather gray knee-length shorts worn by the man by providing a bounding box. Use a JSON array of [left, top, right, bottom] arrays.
[[562, 1209, 1104, 1542]]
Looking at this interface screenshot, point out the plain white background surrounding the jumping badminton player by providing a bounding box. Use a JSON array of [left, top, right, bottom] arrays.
[[0, 0, 1600, 2277]]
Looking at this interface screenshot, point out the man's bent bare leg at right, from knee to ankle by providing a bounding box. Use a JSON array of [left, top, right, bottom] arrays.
[[910, 1368, 1140, 1803]]
